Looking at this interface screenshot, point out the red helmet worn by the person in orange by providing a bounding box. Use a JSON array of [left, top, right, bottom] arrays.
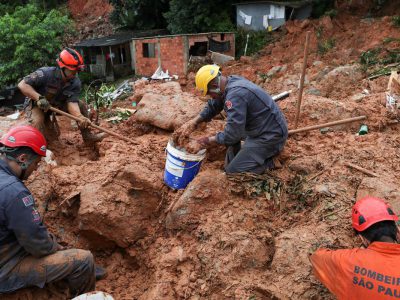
[[352, 196, 398, 231]]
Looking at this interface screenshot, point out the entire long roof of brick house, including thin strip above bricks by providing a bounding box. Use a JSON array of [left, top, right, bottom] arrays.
[[75, 30, 234, 47]]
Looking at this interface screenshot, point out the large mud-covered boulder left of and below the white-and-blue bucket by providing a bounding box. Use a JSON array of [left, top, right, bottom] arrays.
[[78, 164, 162, 248]]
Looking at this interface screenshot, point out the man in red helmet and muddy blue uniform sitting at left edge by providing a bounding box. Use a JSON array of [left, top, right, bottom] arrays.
[[0, 126, 95, 298]]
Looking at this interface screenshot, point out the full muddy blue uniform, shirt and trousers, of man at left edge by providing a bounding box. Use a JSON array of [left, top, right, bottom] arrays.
[[0, 159, 95, 299]]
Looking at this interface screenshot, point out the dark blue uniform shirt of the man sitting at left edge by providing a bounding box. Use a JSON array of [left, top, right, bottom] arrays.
[[0, 159, 57, 293]]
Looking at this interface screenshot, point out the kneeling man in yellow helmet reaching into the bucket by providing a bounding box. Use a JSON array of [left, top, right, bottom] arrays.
[[174, 65, 288, 174]]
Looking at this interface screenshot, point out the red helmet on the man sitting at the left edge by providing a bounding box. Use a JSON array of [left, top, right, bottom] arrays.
[[0, 126, 47, 156]]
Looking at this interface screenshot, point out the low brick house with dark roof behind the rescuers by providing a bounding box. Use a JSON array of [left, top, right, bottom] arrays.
[[75, 31, 235, 81]]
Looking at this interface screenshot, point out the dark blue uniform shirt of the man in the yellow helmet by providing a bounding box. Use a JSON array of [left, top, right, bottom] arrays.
[[200, 76, 288, 147]]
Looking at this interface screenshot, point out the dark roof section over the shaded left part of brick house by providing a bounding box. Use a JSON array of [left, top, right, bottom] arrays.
[[75, 29, 166, 47]]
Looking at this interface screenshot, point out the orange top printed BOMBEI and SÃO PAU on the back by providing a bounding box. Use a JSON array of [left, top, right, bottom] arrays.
[[310, 242, 400, 300]]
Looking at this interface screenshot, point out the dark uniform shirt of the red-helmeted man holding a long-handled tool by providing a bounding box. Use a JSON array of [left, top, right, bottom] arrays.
[[24, 67, 81, 109]]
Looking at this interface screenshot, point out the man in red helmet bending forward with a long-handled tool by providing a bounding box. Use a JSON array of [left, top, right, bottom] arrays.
[[18, 48, 104, 143]]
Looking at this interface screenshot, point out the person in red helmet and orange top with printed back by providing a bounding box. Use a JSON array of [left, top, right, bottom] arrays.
[[310, 196, 400, 300]]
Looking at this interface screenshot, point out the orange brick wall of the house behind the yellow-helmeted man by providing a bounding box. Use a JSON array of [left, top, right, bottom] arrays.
[[134, 33, 235, 77]]
